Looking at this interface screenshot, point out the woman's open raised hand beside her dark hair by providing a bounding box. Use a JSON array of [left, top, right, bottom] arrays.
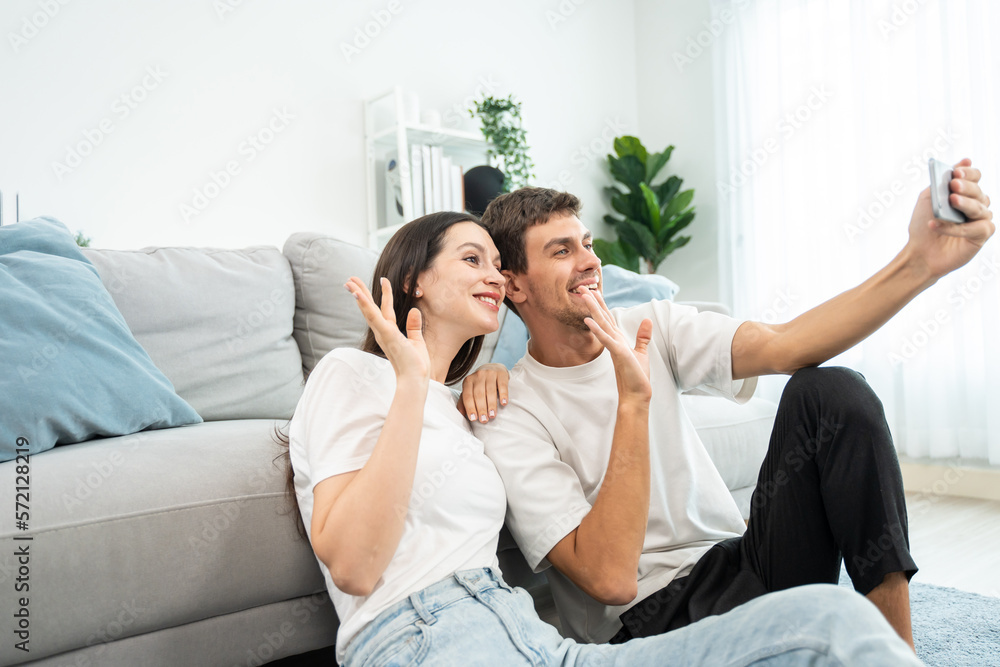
[[344, 276, 431, 380]]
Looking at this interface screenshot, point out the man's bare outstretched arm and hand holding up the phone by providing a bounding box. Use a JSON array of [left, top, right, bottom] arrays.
[[732, 159, 996, 380]]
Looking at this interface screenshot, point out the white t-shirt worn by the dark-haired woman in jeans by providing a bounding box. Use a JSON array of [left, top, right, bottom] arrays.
[[289, 349, 506, 662]]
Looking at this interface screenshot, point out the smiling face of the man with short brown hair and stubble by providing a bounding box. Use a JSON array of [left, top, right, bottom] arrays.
[[518, 214, 601, 333]]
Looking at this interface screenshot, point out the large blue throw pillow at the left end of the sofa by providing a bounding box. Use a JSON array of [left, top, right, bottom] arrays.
[[0, 218, 201, 461]]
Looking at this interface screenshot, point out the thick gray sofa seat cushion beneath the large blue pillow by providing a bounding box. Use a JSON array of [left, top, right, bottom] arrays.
[[0, 420, 325, 665]]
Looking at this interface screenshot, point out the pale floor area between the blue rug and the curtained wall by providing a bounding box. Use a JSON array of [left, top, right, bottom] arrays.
[[906, 493, 1000, 597]]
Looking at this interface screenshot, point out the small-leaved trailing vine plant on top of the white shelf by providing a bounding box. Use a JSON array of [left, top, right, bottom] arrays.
[[469, 95, 535, 192]]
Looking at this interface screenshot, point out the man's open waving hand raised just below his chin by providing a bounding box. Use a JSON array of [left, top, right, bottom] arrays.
[[584, 290, 653, 404]]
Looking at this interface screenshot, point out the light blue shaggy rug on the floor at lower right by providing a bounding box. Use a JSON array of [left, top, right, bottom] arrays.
[[840, 570, 1000, 667]]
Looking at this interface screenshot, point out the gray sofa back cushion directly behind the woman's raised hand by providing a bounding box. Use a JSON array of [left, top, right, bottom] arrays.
[[284, 232, 378, 374]]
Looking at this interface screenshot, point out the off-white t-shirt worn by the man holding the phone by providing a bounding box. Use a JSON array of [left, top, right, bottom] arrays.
[[475, 301, 757, 642]]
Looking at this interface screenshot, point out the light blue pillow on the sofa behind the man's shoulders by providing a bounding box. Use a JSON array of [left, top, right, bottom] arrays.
[[490, 264, 680, 368]]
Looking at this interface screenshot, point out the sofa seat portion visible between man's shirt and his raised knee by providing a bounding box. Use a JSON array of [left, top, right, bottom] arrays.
[[681, 394, 778, 491]]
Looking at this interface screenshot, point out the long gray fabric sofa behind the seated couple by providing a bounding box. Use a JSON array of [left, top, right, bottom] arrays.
[[0, 233, 775, 665]]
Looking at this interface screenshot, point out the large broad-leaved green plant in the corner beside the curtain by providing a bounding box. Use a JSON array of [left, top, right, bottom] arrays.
[[594, 136, 694, 273]]
